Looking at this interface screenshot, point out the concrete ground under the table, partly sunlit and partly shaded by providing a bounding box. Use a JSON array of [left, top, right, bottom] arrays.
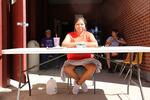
[[0, 69, 150, 100]]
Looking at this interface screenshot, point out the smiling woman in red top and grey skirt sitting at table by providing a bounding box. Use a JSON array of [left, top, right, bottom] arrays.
[[61, 16, 101, 94]]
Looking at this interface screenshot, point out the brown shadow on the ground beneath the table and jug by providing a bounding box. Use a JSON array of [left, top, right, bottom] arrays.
[[0, 83, 107, 100]]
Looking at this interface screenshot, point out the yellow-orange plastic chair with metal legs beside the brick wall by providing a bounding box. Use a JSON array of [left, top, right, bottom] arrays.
[[123, 52, 143, 80]]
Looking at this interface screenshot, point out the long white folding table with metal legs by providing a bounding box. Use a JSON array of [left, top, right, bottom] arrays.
[[2, 46, 150, 100]]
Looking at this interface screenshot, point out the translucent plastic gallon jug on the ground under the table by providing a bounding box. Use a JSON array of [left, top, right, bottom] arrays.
[[46, 78, 57, 95]]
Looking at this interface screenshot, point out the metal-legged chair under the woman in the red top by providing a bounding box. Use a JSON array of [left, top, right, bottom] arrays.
[[68, 66, 96, 94]]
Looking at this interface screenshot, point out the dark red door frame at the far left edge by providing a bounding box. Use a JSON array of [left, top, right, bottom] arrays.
[[0, 0, 10, 87]]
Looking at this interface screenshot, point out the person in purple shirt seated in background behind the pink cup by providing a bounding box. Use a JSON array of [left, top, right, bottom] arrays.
[[40, 30, 54, 69]]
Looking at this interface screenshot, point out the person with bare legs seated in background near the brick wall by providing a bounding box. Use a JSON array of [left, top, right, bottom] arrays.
[[105, 29, 126, 72]]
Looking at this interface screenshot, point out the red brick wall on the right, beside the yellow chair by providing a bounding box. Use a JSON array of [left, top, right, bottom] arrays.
[[118, 0, 150, 71]]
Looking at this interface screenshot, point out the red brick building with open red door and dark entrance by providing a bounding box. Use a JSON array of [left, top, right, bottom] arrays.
[[0, 0, 150, 87]]
